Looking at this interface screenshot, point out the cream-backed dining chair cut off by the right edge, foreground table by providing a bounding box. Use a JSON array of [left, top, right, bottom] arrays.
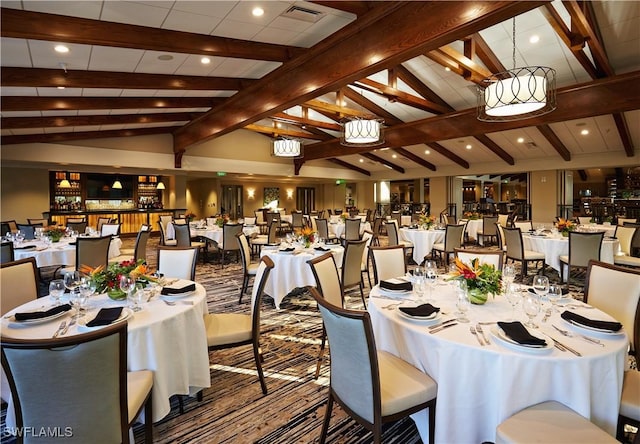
[[584, 261, 640, 441]]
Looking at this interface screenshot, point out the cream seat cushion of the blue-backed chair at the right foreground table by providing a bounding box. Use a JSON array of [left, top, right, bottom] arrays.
[[378, 351, 438, 416]]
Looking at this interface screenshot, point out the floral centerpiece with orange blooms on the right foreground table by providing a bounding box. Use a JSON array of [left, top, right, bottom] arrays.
[[448, 258, 502, 305]]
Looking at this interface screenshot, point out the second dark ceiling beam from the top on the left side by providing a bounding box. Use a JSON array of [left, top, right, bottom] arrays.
[[0, 67, 256, 91]]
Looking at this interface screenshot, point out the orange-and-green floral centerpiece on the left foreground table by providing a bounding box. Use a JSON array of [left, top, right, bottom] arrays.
[[79, 259, 157, 301]]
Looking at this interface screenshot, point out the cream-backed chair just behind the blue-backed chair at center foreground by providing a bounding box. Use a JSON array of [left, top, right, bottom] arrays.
[[307, 252, 344, 379]]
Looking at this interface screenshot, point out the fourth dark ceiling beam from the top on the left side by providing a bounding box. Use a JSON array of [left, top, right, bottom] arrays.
[[0, 113, 203, 129]]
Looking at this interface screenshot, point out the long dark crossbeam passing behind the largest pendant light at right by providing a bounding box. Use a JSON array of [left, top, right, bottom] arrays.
[[305, 71, 640, 162]]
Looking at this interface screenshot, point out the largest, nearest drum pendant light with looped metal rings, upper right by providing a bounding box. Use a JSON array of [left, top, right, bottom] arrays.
[[477, 17, 556, 122]]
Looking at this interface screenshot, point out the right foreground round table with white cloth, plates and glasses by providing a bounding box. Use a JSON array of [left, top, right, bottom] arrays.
[[367, 264, 629, 443]]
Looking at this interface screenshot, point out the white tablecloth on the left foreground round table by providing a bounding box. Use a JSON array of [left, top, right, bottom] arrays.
[[1, 284, 211, 427]]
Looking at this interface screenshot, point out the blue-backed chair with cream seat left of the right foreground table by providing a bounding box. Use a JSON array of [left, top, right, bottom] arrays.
[[310, 288, 437, 444]]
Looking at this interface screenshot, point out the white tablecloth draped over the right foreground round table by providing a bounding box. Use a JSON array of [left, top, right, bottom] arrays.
[[368, 284, 629, 444]]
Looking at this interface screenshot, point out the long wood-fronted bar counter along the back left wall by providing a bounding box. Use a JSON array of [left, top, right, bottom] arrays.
[[42, 208, 187, 235]]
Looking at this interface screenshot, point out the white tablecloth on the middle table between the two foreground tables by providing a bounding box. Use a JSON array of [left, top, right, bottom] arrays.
[[261, 245, 344, 309]]
